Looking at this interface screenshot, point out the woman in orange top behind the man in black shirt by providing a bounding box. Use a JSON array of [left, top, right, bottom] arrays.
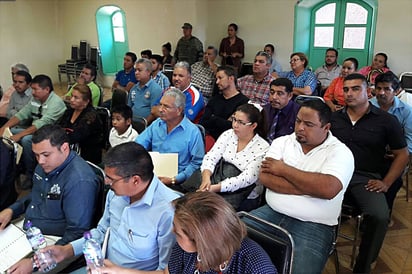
[[323, 57, 358, 111]]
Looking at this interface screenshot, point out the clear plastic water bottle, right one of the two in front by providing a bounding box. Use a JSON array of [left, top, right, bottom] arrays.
[[83, 231, 103, 273]]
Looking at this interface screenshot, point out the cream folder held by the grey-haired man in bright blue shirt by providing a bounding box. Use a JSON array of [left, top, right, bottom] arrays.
[[149, 151, 178, 178]]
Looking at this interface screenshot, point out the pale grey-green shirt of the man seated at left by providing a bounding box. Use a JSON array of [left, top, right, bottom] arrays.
[[15, 91, 66, 129]]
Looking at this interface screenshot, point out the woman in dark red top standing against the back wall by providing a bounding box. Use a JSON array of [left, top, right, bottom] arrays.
[[219, 23, 245, 71]]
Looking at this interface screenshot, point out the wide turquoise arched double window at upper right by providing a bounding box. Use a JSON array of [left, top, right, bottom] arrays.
[[294, 0, 377, 68]]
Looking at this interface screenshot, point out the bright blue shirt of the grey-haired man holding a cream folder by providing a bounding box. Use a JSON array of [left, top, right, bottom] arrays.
[[136, 116, 205, 183]]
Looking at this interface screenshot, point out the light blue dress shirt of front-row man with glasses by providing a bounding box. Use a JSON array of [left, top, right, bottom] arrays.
[[71, 176, 178, 270]]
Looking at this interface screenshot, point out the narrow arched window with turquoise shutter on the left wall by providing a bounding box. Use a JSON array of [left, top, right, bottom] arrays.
[[96, 5, 129, 74]]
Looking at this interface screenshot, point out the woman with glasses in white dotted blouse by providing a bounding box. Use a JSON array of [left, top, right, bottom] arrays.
[[199, 104, 269, 210]]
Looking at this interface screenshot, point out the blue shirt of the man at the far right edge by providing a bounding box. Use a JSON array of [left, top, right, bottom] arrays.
[[369, 96, 412, 153]]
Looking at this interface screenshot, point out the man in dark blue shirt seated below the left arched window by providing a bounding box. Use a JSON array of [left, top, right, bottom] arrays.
[[109, 52, 137, 92]]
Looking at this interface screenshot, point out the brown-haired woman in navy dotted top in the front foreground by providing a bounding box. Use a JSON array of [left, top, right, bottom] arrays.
[[100, 192, 277, 274]]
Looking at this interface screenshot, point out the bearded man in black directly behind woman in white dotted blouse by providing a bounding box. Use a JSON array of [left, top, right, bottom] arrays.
[[200, 66, 249, 140]]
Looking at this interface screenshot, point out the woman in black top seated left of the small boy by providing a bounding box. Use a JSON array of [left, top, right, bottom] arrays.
[[59, 84, 104, 164]]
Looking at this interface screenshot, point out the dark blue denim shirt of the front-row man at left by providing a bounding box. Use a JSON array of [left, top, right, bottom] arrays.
[[10, 152, 98, 245]]
